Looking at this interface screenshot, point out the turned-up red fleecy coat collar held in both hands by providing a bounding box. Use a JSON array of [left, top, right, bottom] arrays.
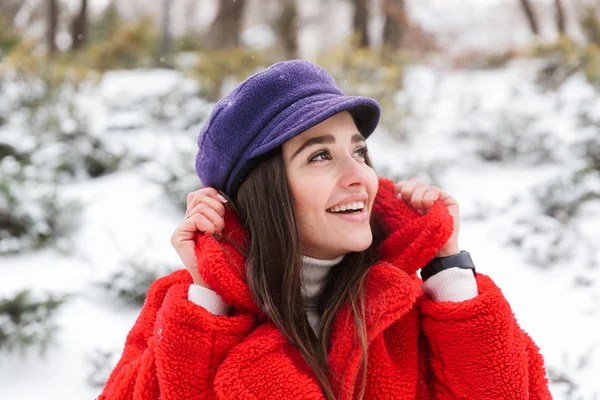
[[195, 178, 452, 314]]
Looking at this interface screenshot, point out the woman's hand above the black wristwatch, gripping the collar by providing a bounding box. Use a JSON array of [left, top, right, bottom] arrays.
[[394, 178, 460, 257]]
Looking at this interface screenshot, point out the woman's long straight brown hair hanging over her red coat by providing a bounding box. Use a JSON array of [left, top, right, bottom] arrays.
[[227, 147, 382, 400]]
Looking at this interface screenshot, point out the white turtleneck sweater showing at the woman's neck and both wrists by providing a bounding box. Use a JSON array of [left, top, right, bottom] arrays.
[[188, 256, 479, 332]]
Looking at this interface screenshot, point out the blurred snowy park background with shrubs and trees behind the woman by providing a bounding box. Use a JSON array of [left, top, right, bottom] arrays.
[[0, 0, 600, 400]]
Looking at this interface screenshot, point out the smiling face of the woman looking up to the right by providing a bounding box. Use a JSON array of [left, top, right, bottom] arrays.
[[283, 111, 378, 259]]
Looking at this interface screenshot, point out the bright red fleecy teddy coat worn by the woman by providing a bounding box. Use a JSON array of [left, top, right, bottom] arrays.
[[99, 179, 551, 400]]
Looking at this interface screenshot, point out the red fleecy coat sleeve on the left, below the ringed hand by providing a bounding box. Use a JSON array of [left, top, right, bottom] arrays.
[[98, 270, 254, 400]]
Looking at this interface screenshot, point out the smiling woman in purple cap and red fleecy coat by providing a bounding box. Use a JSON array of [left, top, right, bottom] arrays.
[[100, 61, 550, 400]]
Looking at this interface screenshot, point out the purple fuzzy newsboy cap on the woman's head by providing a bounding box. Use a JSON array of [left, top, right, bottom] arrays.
[[196, 60, 381, 196]]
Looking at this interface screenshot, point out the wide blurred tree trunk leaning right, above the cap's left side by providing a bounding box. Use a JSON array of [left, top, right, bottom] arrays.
[[206, 0, 245, 50]]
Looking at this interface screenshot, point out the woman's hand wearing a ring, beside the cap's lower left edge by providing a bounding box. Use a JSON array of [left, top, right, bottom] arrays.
[[171, 187, 227, 287]]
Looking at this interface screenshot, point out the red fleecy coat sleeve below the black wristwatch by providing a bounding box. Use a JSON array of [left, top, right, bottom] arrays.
[[419, 274, 552, 400]]
